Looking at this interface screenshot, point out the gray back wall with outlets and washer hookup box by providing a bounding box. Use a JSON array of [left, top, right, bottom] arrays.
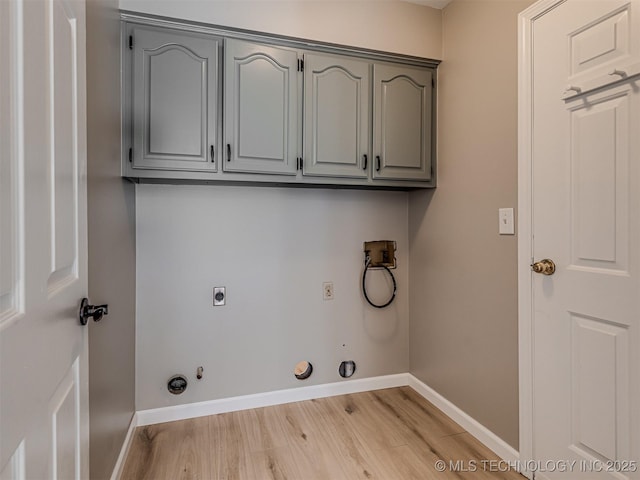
[[136, 185, 409, 410]]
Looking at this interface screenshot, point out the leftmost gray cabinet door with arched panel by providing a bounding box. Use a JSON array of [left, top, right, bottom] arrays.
[[131, 27, 219, 171]]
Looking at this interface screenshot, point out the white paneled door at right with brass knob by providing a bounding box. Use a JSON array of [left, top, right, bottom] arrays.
[[521, 0, 640, 479]]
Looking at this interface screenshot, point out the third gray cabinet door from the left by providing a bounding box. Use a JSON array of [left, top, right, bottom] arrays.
[[303, 54, 371, 178]]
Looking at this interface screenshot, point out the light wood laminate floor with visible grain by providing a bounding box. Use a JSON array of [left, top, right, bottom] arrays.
[[121, 387, 524, 480]]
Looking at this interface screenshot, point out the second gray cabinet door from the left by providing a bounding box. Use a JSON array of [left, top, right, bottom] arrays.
[[224, 39, 298, 175]]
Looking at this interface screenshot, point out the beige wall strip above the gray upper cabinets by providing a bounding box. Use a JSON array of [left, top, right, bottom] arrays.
[[120, 0, 442, 58]]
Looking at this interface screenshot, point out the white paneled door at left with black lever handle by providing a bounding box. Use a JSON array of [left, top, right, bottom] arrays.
[[0, 0, 89, 480]]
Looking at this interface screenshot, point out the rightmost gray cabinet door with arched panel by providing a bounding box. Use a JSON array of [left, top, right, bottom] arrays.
[[373, 65, 433, 181]]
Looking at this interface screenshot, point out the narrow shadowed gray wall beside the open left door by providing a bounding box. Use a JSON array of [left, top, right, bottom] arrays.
[[87, 0, 135, 479]]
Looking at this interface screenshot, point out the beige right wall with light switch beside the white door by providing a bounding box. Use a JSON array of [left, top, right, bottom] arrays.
[[409, 0, 532, 449]]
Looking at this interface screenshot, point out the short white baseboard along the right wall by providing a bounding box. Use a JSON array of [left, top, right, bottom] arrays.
[[407, 374, 520, 464]]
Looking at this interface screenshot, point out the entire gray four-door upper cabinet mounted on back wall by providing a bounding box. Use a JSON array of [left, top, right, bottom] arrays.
[[121, 15, 438, 189]]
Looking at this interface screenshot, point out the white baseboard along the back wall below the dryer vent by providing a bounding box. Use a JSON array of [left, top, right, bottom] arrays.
[[137, 373, 408, 426]]
